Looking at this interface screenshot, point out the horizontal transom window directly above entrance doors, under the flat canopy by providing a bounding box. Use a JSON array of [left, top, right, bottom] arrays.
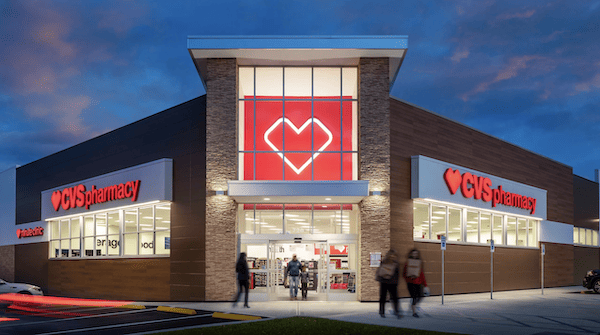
[[237, 204, 359, 234]]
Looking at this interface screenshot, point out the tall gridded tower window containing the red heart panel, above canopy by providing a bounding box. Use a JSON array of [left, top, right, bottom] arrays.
[[238, 67, 358, 180]]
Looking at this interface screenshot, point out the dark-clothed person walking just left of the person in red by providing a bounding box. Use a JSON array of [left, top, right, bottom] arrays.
[[375, 249, 401, 319]]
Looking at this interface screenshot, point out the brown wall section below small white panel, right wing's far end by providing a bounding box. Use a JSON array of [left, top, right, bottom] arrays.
[[544, 243, 575, 287]]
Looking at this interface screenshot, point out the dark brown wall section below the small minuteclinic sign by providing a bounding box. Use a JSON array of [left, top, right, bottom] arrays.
[[15, 242, 48, 293]]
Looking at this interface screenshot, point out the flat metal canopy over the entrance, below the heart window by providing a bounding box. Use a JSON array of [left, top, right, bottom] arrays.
[[227, 180, 369, 204]]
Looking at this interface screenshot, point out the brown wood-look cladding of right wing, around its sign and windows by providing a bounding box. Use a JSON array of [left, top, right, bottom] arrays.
[[390, 98, 574, 295]]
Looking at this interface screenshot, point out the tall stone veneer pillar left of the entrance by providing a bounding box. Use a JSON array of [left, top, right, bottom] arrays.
[[205, 59, 237, 301]]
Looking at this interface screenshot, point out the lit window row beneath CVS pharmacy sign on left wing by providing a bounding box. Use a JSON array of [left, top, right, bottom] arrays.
[[49, 203, 171, 258]]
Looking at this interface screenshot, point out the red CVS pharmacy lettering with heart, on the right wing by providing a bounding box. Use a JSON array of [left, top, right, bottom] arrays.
[[444, 168, 537, 215]]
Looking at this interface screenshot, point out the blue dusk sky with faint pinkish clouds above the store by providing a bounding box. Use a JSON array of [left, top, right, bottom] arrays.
[[0, 0, 600, 180]]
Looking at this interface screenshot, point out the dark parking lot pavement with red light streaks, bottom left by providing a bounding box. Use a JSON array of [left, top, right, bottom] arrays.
[[0, 296, 264, 335]]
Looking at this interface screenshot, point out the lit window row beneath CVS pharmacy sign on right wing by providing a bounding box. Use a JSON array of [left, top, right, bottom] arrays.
[[413, 201, 539, 247]]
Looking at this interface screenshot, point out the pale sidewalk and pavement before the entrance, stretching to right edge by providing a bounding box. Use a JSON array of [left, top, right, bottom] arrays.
[[141, 286, 600, 335]]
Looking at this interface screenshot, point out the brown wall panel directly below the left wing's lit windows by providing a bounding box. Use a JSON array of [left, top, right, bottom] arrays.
[[45, 258, 170, 301]]
